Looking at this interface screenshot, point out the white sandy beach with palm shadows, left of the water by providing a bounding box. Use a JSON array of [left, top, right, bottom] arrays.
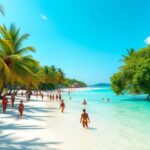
[[0, 96, 96, 150]]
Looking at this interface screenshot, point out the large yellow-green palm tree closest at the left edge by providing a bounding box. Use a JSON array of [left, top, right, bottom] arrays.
[[0, 25, 37, 95]]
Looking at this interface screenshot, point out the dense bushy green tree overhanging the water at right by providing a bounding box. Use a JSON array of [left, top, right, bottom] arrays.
[[111, 46, 150, 98]]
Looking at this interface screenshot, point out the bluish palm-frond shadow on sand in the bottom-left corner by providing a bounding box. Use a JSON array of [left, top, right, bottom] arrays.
[[0, 134, 62, 150]]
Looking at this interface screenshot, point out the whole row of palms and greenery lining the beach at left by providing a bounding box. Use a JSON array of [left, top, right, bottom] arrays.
[[0, 24, 86, 96]]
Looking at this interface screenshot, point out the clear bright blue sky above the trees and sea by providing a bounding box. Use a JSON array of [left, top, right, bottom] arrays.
[[0, 0, 150, 84]]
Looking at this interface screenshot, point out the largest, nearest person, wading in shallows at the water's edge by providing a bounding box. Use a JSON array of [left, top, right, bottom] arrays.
[[80, 109, 90, 128]]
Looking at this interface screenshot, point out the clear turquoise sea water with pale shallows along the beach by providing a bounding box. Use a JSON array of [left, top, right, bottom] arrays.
[[63, 88, 150, 150]]
